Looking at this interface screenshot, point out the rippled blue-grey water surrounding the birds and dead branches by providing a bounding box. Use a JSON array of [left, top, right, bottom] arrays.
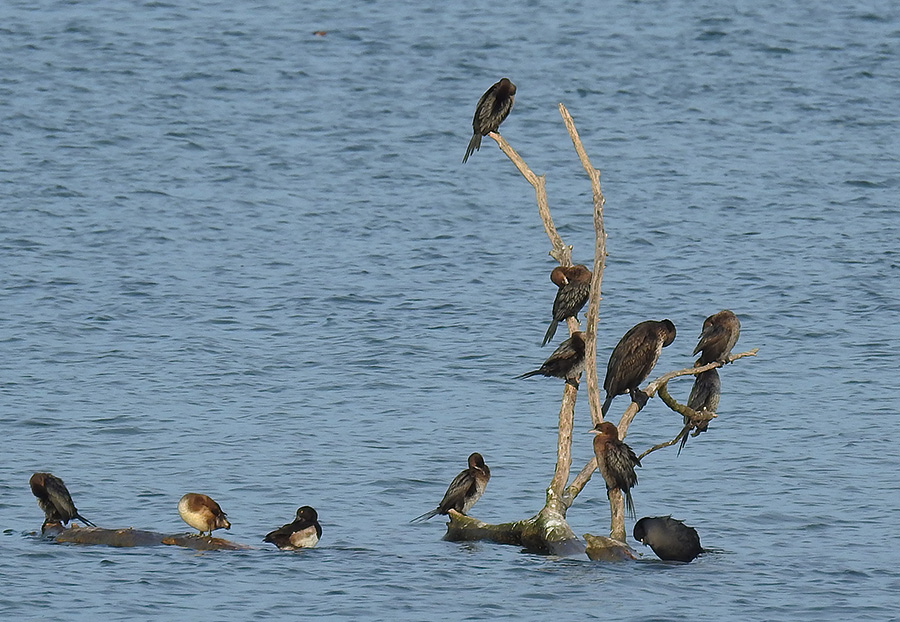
[[0, 0, 900, 620]]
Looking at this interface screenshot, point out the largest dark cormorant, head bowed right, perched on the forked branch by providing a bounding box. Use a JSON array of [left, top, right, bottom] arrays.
[[600, 320, 675, 415]]
